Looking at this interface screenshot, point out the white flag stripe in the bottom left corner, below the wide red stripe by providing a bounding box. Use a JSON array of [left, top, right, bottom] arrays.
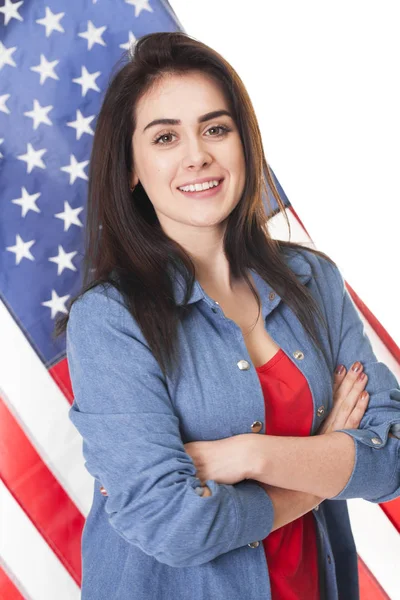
[[0, 481, 80, 600]]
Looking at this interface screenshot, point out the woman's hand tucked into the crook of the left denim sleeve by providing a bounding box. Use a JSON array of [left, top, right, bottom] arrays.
[[184, 433, 253, 485]]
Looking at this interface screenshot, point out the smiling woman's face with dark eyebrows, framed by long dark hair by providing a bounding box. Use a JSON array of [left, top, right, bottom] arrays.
[[130, 72, 245, 240]]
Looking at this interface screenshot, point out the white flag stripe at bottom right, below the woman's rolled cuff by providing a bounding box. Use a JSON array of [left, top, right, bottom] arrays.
[[347, 499, 400, 600]]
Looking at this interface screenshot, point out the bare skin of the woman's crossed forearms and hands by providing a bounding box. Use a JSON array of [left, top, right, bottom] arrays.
[[185, 360, 367, 529]]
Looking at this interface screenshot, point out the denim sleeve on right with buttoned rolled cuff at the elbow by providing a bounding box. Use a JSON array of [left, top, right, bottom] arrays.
[[324, 261, 400, 502]]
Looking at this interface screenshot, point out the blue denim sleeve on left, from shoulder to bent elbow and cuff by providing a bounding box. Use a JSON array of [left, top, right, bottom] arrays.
[[67, 290, 274, 567]]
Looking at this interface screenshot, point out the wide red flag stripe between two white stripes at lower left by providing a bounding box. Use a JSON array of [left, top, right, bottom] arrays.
[[0, 397, 85, 585]]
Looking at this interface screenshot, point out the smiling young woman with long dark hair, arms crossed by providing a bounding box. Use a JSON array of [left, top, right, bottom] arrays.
[[57, 33, 400, 600]]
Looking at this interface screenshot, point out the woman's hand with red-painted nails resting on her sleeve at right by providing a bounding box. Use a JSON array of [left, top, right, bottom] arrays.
[[318, 362, 369, 435]]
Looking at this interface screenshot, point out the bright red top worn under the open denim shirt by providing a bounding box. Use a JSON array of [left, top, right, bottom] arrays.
[[256, 349, 319, 600]]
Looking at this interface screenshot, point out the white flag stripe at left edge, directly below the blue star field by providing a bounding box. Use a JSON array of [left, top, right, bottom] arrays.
[[0, 301, 93, 516]]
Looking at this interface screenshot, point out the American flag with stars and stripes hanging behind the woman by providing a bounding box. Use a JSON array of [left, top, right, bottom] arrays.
[[0, 0, 400, 600]]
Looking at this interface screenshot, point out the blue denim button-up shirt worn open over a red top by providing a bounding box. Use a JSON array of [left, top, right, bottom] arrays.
[[67, 249, 400, 600]]
